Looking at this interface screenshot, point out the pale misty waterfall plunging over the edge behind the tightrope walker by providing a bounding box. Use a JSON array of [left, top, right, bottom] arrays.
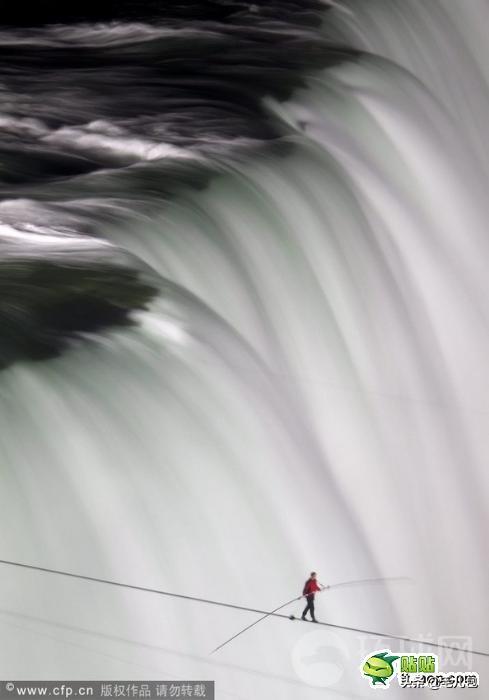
[[0, 0, 489, 700]]
